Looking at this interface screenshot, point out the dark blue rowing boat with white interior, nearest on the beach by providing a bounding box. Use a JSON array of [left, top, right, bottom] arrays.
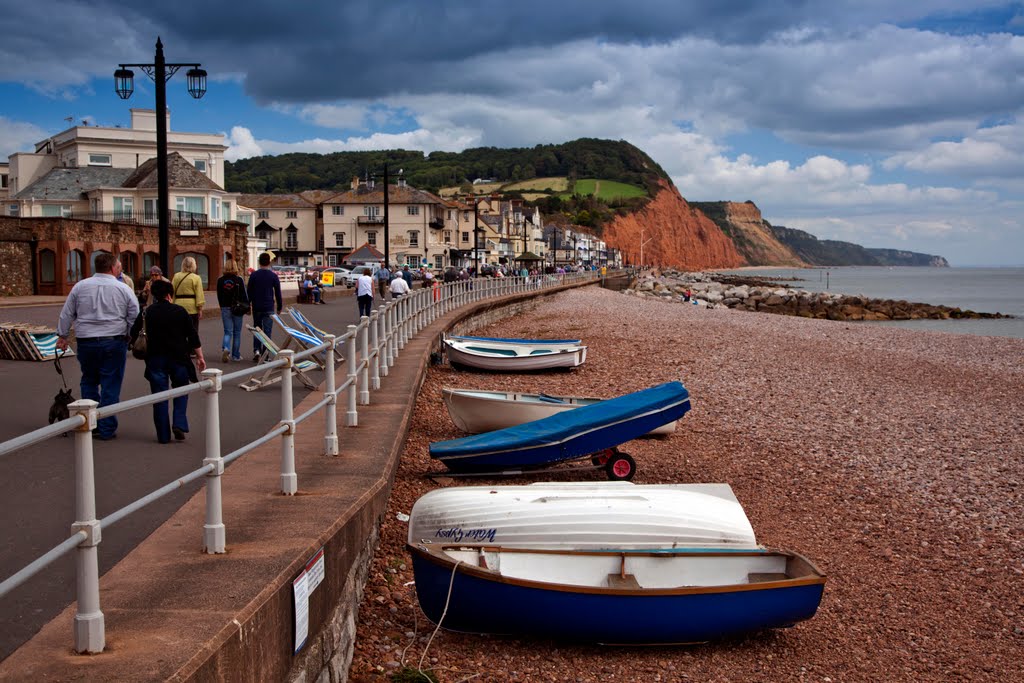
[[409, 544, 825, 645]]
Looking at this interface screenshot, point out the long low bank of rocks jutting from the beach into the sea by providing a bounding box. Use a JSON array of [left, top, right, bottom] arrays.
[[625, 269, 1011, 321]]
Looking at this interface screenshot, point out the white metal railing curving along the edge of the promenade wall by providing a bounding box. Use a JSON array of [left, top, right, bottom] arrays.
[[0, 272, 596, 653]]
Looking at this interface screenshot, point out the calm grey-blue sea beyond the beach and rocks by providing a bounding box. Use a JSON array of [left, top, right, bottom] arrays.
[[724, 266, 1024, 339]]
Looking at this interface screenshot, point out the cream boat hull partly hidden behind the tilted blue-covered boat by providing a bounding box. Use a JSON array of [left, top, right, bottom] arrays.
[[441, 388, 676, 436]]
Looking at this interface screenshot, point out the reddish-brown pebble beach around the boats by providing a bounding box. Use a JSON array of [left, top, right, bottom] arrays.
[[350, 288, 1024, 683]]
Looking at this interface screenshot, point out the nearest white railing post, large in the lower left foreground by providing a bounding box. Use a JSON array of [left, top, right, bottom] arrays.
[[68, 398, 106, 653]]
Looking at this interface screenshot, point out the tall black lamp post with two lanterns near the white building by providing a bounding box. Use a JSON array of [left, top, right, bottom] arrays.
[[114, 36, 206, 274]]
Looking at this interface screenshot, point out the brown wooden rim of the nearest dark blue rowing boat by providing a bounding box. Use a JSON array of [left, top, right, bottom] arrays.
[[406, 544, 827, 597]]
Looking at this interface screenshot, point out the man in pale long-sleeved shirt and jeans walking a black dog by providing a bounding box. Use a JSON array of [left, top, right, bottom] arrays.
[[56, 253, 138, 441]]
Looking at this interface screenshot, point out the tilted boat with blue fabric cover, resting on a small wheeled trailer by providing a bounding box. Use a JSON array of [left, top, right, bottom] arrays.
[[430, 382, 690, 469]]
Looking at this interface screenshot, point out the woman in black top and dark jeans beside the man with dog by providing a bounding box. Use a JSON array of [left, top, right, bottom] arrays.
[[131, 280, 206, 443]]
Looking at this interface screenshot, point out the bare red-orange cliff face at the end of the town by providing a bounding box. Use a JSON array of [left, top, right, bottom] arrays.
[[602, 181, 746, 270]]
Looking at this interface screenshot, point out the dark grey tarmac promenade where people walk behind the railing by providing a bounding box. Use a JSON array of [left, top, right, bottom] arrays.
[[0, 289, 379, 659]]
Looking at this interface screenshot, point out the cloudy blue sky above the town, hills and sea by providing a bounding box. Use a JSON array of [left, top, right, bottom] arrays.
[[0, 0, 1024, 266]]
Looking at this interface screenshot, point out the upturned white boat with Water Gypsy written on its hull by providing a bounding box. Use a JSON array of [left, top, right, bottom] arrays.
[[409, 481, 760, 550]]
